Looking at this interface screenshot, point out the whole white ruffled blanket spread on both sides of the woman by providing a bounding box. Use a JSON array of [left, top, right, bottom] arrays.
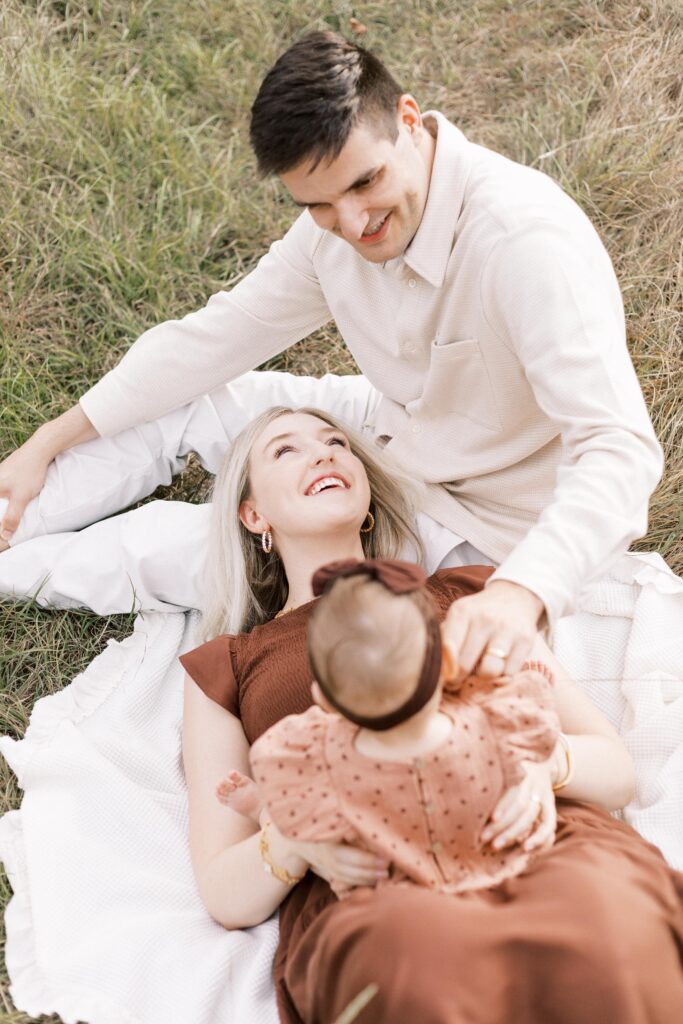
[[0, 542, 683, 1024]]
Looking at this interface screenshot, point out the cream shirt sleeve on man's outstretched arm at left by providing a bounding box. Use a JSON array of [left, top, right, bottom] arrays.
[[80, 212, 331, 435]]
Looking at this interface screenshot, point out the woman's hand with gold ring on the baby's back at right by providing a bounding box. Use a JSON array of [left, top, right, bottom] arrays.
[[481, 755, 557, 851]]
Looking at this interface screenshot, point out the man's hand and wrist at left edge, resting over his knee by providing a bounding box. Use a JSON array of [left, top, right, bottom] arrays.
[[0, 404, 98, 552]]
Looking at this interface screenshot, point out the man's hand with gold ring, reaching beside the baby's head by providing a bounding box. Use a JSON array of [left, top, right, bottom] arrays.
[[441, 580, 544, 682]]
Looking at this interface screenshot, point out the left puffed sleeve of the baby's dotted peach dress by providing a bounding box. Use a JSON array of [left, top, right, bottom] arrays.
[[249, 708, 355, 843]]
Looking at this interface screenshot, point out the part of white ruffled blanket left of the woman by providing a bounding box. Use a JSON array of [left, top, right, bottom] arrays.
[[0, 611, 278, 1024]]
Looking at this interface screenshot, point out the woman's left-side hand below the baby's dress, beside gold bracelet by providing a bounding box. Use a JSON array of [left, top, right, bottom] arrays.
[[268, 824, 389, 886]]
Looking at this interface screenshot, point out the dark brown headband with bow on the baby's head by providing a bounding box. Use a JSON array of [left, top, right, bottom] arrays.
[[308, 558, 441, 732]]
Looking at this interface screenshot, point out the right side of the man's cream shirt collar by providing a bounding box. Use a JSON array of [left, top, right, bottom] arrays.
[[402, 111, 472, 288]]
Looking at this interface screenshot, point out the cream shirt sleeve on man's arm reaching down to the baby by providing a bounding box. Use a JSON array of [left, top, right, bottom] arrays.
[[482, 219, 663, 623]]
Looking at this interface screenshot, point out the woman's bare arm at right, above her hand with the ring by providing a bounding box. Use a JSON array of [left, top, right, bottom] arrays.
[[529, 636, 636, 811]]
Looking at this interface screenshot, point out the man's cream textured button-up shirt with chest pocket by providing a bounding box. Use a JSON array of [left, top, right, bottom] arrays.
[[81, 113, 663, 623]]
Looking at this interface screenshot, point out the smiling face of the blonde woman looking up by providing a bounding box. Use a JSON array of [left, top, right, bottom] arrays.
[[240, 413, 371, 546]]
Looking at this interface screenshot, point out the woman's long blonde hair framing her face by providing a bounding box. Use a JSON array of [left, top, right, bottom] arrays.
[[200, 406, 424, 641]]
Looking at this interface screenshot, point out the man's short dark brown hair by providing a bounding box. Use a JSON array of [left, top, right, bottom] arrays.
[[250, 32, 403, 175]]
